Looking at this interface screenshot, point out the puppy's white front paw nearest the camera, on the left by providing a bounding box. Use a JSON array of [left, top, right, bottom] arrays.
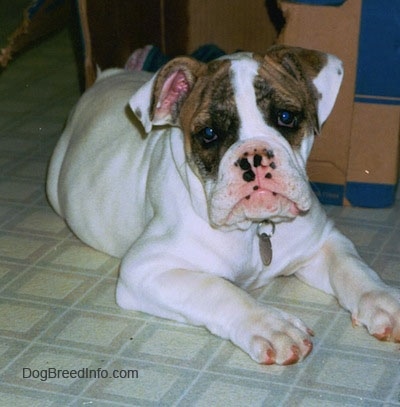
[[233, 308, 313, 365]]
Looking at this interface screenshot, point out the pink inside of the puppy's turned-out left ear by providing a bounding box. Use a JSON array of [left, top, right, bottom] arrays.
[[154, 71, 189, 120]]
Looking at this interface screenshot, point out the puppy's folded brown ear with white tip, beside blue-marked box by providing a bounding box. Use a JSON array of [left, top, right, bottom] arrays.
[[266, 45, 343, 129]]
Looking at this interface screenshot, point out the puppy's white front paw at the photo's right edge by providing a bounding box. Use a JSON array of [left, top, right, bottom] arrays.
[[352, 290, 400, 342]]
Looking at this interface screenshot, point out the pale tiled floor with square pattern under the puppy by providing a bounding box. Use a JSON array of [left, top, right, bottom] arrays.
[[0, 28, 400, 407]]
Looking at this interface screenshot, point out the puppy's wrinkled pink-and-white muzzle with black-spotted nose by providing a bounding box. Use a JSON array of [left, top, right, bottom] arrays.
[[210, 140, 312, 227]]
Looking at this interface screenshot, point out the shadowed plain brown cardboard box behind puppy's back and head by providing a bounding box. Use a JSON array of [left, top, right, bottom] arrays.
[[79, 0, 277, 86]]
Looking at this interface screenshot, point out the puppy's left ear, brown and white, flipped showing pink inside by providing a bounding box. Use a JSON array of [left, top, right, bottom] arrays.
[[129, 57, 204, 132]]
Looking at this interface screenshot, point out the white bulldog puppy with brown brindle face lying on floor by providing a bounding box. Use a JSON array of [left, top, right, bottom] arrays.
[[47, 46, 400, 365]]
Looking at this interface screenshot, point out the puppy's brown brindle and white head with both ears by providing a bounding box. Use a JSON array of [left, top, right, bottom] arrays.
[[130, 46, 343, 228]]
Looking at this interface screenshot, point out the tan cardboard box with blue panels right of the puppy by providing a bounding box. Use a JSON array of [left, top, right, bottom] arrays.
[[278, 0, 400, 207]]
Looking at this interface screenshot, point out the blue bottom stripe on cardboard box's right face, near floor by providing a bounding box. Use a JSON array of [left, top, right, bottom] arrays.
[[346, 182, 396, 208]]
